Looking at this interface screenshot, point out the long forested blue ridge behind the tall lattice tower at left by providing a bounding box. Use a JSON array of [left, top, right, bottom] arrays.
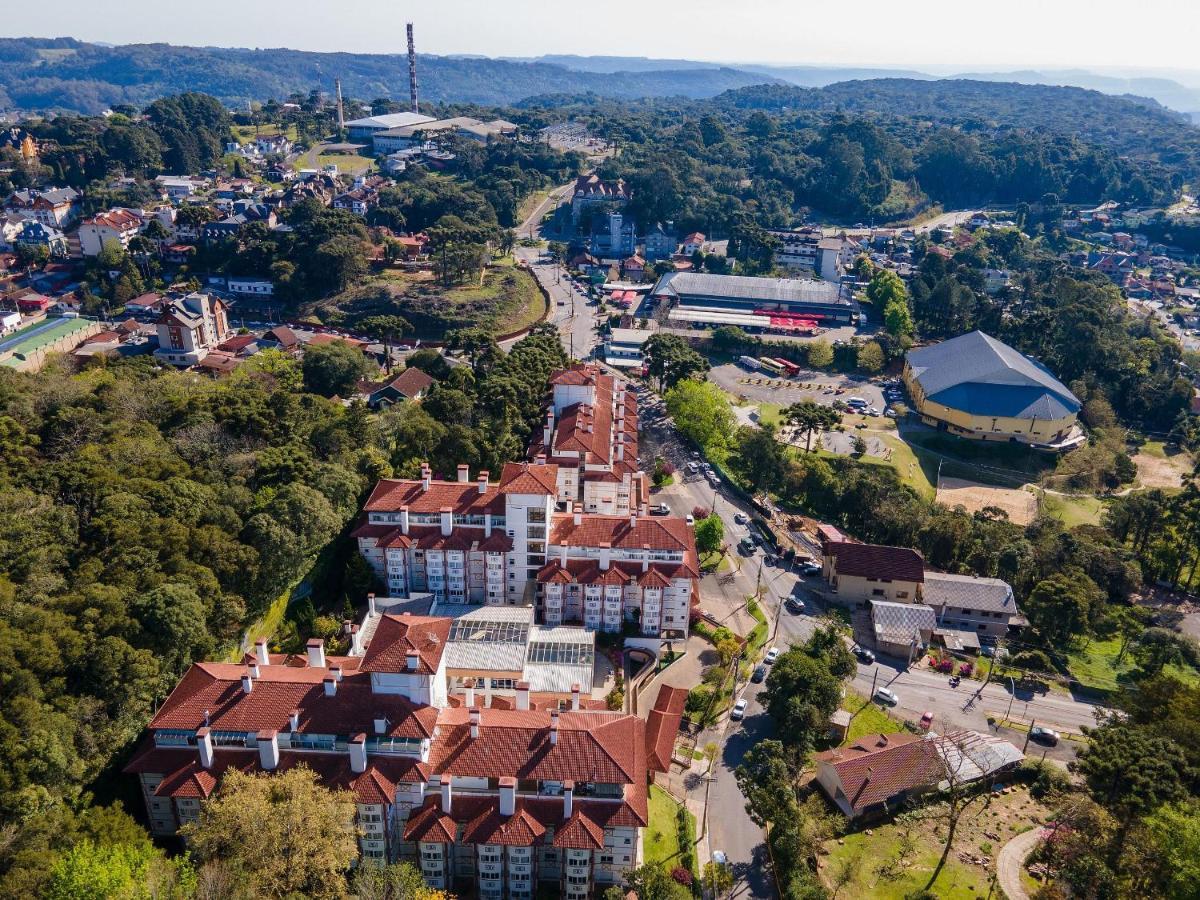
[[0, 38, 772, 113]]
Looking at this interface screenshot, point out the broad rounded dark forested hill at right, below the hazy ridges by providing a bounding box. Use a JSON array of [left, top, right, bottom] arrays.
[[714, 78, 1200, 176]]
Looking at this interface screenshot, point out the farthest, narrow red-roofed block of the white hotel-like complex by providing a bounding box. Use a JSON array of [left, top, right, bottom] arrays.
[[529, 364, 649, 516]]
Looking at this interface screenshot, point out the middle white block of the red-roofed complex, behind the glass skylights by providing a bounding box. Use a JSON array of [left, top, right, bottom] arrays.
[[353, 462, 700, 637]]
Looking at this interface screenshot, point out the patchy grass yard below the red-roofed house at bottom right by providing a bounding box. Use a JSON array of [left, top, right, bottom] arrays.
[[817, 787, 1046, 900]]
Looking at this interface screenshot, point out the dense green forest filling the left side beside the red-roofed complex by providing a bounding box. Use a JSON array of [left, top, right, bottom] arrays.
[[0, 326, 565, 898]]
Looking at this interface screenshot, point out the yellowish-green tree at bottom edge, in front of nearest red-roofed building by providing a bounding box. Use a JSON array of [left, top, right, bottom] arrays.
[[181, 766, 358, 898]]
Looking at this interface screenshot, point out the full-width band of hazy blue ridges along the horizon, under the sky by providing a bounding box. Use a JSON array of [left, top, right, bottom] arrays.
[[0, 37, 1200, 121]]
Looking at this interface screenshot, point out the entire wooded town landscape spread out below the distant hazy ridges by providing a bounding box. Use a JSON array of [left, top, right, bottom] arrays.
[[0, 12, 1200, 900]]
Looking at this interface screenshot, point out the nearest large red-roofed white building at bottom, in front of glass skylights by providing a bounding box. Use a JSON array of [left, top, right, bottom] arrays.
[[125, 599, 648, 900]]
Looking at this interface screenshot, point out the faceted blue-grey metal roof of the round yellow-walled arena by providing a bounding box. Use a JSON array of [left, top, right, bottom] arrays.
[[907, 331, 1081, 419]]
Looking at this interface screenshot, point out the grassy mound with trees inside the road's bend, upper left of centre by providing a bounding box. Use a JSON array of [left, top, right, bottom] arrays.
[[319, 263, 546, 341]]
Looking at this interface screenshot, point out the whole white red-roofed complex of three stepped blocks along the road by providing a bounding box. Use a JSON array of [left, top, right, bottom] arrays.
[[125, 365, 698, 900]]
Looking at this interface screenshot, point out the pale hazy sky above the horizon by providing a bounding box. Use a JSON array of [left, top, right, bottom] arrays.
[[0, 0, 1200, 70]]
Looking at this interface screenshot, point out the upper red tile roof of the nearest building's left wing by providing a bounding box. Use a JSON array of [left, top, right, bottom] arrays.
[[150, 662, 449, 738]]
